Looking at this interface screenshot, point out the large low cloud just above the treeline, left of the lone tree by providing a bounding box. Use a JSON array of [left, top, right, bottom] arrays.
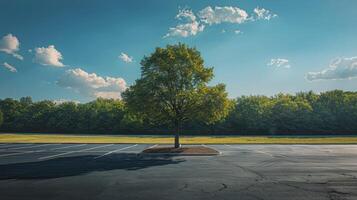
[[57, 68, 127, 99]]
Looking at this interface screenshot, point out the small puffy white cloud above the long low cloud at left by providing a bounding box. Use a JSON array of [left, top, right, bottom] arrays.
[[35, 45, 65, 67]]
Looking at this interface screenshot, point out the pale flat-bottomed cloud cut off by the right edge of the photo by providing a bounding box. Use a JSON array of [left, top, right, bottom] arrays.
[[306, 57, 357, 81]]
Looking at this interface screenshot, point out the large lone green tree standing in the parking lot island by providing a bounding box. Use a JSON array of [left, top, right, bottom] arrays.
[[123, 44, 230, 148]]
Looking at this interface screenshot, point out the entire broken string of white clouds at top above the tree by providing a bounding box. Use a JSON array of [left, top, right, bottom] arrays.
[[164, 6, 277, 37]]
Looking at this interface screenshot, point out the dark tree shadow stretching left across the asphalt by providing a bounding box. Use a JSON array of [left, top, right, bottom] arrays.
[[0, 153, 185, 180]]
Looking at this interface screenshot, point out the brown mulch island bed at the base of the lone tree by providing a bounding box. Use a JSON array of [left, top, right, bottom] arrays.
[[142, 146, 219, 155]]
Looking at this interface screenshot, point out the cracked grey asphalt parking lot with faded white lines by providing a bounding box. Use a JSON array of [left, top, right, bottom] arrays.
[[0, 144, 357, 200]]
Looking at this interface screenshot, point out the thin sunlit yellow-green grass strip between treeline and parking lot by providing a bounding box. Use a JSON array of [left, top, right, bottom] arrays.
[[0, 133, 357, 144]]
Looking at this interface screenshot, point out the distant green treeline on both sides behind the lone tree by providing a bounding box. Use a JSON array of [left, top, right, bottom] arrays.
[[0, 90, 357, 134]]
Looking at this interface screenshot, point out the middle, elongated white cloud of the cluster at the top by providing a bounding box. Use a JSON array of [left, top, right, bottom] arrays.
[[198, 6, 248, 25]]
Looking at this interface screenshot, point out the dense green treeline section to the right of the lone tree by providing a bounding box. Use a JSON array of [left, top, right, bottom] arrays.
[[220, 90, 357, 131]]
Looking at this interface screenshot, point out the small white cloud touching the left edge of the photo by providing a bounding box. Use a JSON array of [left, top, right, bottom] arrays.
[[0, 33, 24, 60]]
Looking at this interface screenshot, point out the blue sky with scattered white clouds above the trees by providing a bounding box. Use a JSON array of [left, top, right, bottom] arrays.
[[0, 0, 357, 102]]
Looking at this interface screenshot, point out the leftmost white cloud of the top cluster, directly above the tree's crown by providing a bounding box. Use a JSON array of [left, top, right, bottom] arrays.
[[164, 9, 205, 38]]
